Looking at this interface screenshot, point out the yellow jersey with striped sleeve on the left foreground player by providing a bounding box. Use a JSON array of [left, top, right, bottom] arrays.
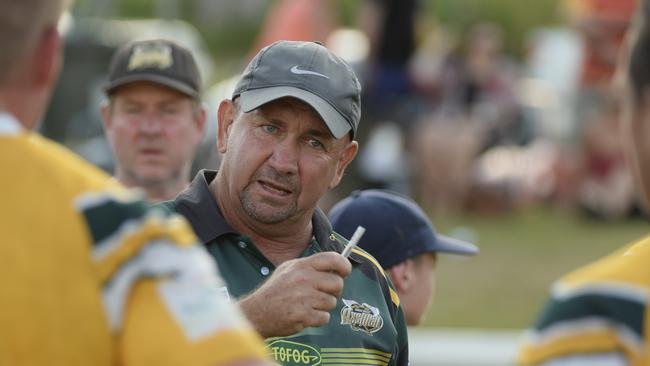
[[0, 113, 265, 365]]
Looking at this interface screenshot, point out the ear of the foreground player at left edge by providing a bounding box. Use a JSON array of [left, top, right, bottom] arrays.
[[31, 26, 62, 88]]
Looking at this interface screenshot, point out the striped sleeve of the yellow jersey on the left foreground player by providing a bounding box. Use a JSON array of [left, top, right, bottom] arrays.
[[77, 191, 266, 365]]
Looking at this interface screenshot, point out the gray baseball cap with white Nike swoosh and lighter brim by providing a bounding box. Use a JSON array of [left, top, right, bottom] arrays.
[[232, 41, 361, 139]]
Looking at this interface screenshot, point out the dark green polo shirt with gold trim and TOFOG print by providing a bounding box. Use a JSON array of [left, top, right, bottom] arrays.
[[161, 170, 408, 366]]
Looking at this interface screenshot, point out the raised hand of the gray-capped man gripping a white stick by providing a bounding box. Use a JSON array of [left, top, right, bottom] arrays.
[[239, 252, 352, 338]]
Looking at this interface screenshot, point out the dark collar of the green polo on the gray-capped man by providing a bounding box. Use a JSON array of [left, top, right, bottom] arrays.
[[174, 169, 343, 252]]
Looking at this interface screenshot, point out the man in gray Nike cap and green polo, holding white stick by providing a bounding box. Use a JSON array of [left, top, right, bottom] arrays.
[[158, 41, 408, 365]]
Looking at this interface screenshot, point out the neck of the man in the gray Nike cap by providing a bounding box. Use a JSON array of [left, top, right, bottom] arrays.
[[210, 176, 313, 266]]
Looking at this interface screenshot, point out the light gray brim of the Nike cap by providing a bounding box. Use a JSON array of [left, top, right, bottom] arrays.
[[239, 86, 352, 139]]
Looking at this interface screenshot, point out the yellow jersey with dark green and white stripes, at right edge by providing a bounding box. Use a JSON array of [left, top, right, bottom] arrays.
[[518, 237, 650, 366]]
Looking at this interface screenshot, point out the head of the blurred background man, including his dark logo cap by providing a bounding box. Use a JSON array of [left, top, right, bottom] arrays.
[[102, 39, 206, 201]]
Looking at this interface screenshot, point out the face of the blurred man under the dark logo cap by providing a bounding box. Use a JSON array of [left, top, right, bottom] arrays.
[[102, 82, 205, 187]]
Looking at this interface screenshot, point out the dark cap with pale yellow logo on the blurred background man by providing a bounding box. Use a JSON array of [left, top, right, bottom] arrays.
[[104, 39, 201, 99]]
